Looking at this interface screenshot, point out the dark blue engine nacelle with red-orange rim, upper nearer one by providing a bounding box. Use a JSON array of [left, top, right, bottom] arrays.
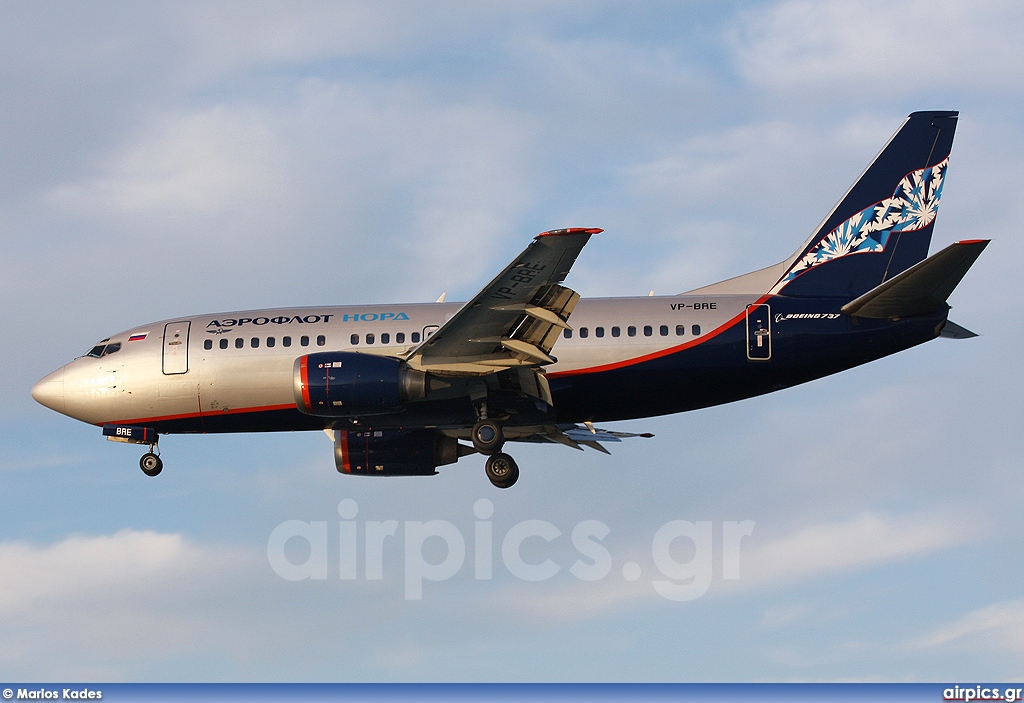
[[292, 352, 426, 418]]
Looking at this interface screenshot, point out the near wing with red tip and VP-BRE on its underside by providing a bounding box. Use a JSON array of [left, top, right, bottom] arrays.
[[406, 228, 602, 376]]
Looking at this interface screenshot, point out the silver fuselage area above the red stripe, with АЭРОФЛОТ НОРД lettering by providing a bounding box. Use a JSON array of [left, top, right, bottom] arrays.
[[33, 296, 754, 425]]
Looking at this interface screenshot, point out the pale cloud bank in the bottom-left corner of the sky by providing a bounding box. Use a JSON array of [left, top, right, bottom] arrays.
[[0, 530, 254, 679]]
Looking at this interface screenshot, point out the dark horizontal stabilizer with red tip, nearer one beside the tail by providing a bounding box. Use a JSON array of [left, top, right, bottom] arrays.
[[843, 239, 988, 319]]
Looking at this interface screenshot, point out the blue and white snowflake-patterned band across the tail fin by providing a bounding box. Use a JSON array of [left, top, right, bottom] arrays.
[[780, 158, 949, 284]]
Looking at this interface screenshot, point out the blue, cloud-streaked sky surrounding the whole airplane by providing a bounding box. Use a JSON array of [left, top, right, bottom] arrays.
[[0, 0, 1024, 683]]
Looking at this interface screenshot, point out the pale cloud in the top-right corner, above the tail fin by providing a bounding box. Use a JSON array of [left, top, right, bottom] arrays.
[[730, 0, 1024, 92]]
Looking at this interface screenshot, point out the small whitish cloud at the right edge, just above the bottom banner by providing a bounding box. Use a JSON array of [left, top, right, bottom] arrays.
[[907, 599, 1024, 654]]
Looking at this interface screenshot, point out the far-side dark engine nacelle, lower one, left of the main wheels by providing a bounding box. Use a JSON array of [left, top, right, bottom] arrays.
[[334, 430, 473, 476]]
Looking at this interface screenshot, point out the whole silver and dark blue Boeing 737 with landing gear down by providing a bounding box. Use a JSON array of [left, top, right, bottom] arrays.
[[32, 112, 989, 488]]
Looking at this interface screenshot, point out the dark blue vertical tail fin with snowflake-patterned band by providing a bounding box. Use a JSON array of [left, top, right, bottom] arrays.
[[772, 112, 958, 300]]
